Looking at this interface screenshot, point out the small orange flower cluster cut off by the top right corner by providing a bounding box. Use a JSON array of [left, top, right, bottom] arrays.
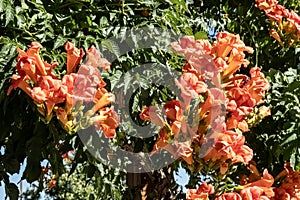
[[255, 0, 300, 46]]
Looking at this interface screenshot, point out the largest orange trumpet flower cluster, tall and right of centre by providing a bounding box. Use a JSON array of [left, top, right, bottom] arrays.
[[140, 32, 270, 174]]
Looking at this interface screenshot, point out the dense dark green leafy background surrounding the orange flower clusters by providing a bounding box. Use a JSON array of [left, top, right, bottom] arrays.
[[0, 0, 300, 199]]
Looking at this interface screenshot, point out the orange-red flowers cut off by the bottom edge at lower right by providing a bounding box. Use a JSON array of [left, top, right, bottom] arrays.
[[186, 163, 300, 200]]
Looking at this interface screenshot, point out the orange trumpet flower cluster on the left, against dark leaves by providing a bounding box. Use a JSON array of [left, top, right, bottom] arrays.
[[7, 42, 119, 138]]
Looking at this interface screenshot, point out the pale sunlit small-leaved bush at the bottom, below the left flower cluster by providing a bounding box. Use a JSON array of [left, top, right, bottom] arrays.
[[46, 164, 125, 200]]
